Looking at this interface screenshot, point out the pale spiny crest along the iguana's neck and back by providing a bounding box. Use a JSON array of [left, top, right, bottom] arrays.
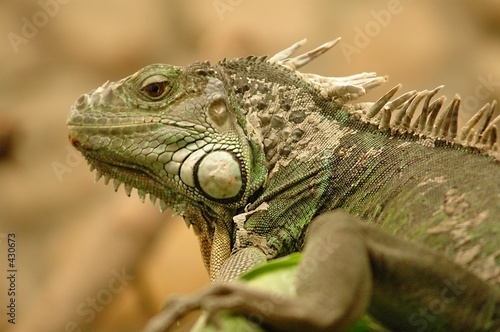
[[267, 38, 500, 161]]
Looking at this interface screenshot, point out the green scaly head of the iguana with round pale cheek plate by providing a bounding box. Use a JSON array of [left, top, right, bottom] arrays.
[[68, 63, 268, 213]]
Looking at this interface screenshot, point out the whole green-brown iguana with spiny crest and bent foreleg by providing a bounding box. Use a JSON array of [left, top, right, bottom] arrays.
[[67, 39, 500, 331]]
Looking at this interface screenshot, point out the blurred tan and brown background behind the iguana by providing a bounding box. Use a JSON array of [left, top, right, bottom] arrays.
[[0, 0, 500, 332]]
